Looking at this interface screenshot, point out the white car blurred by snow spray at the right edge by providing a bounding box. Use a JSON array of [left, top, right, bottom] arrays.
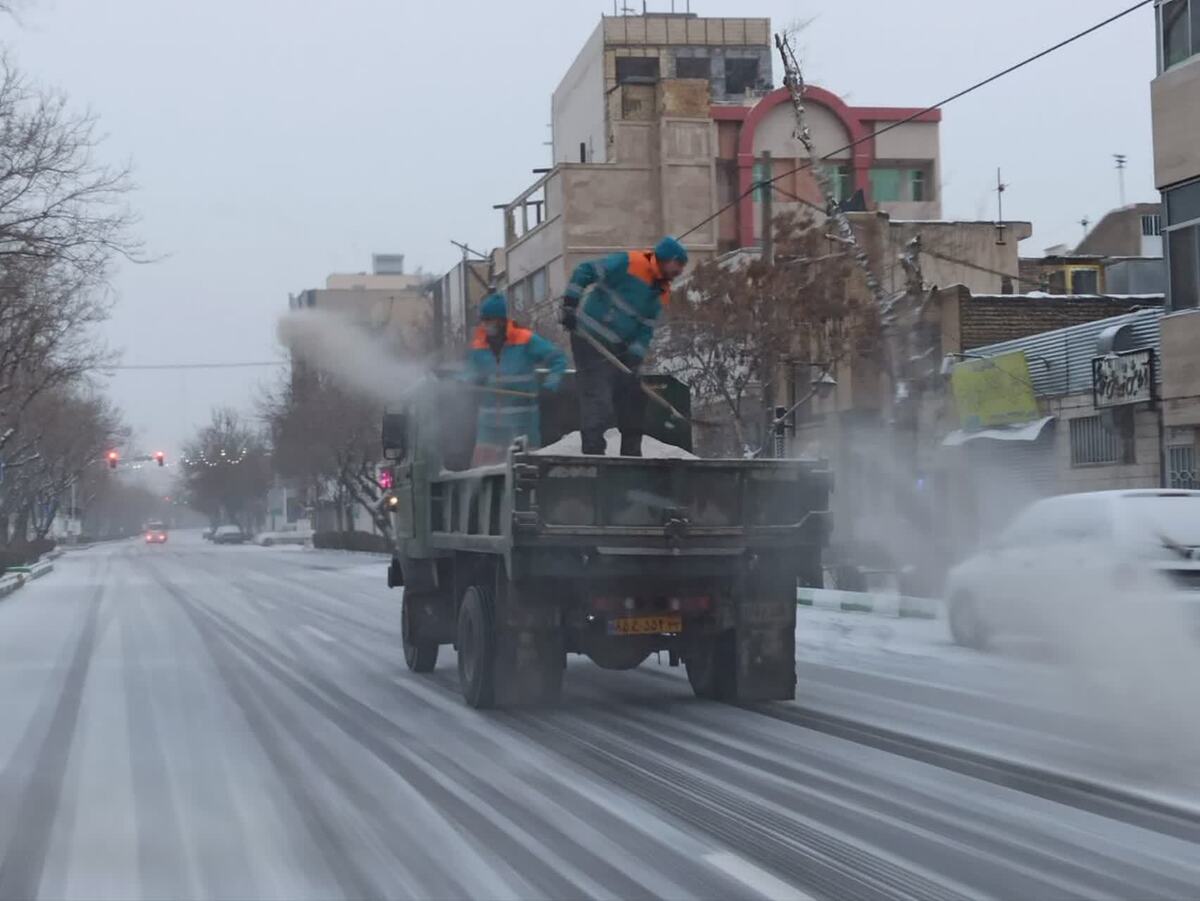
[[946, 489, 1200, 648]]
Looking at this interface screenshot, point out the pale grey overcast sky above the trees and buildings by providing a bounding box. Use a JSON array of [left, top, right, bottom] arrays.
[[0, 0, 1157, 453]]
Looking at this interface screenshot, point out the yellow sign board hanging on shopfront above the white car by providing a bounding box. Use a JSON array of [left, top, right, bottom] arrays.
[[950, 350, 1039, 432]]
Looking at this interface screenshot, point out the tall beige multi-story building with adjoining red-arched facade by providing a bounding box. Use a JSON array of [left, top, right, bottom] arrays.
[[504, 14, 942, 321]]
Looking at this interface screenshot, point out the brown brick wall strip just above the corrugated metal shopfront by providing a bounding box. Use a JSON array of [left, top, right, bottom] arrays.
[[959, 292, 1150, 350]]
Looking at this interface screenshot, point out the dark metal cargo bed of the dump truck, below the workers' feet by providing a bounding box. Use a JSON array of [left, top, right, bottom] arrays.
[[428, 453, 830, 555]]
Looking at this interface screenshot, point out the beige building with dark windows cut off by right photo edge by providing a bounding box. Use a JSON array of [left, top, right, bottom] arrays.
[[1151, 0, 1200, 487]]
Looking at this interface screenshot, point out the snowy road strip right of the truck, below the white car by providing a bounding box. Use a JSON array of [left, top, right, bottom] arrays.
[[796, 607, 1200, 809]]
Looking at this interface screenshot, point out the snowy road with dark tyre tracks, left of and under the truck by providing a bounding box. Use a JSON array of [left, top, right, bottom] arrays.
[[0, 534, 1200, 901]]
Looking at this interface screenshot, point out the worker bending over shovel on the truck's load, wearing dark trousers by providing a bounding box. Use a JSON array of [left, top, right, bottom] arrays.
[[562, 238, 688, 457]]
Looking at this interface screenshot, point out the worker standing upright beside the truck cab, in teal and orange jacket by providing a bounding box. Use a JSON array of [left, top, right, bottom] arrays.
[[466, 294, 566, 465]]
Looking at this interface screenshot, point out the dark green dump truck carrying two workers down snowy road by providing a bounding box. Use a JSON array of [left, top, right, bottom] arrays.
[[383, 373, 830, 708]]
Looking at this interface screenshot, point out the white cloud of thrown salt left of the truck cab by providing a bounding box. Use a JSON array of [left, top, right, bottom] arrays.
[[276, 310, 430, 404]]
